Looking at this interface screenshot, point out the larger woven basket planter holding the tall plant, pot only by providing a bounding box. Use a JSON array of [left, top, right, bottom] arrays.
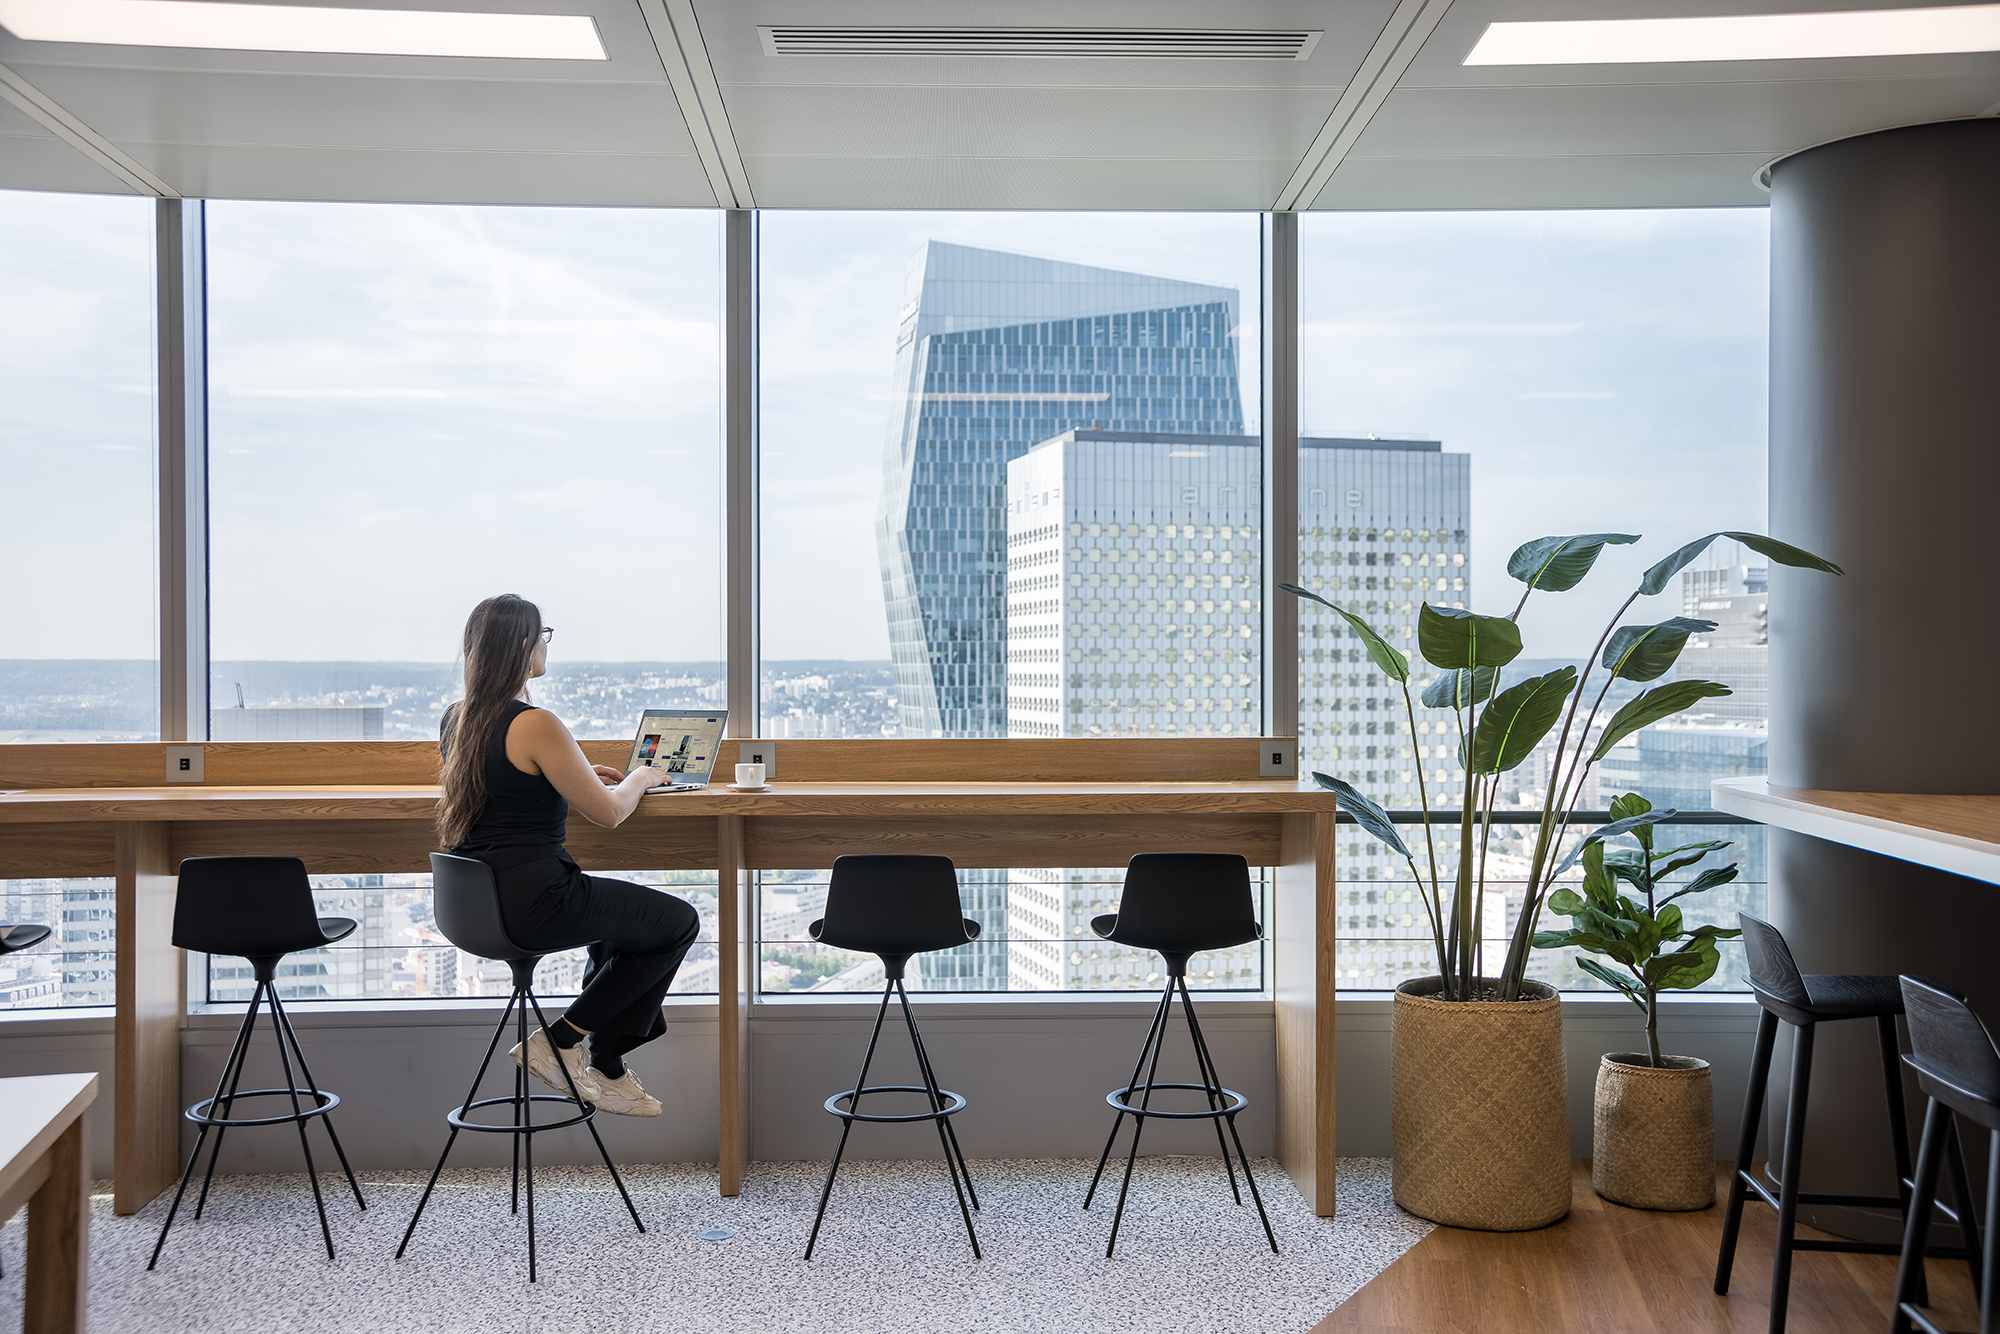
[[1390, 978, 1570, 1232]]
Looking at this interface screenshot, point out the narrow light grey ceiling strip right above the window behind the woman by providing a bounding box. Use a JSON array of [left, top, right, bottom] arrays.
[[118, 142, 716, 208]]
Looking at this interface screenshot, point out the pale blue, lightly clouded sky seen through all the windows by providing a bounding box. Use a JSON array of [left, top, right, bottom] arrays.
[[0, 192, 1784, 662]]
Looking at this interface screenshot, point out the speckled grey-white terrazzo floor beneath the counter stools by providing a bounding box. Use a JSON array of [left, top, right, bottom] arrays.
[[0, 1158, 1430, 1334]]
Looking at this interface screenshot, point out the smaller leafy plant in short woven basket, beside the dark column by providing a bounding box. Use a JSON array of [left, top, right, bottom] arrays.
[[1534, 792, 1742, 1210]]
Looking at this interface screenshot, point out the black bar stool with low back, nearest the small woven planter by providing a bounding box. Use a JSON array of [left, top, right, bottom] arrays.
[[1716, 912, 1978, 1334]]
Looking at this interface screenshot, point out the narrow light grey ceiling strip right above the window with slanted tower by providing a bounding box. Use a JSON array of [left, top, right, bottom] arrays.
[[744, 156, 1294, 210]]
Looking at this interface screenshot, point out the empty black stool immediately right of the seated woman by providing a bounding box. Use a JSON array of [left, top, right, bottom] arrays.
[[806, 856, 982, 1260]]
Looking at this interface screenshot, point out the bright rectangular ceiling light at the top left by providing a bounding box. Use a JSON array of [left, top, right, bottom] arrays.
[[0, 0, 610, 60]]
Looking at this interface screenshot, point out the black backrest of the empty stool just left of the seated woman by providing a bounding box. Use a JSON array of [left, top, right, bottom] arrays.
[[174, 856, 326, 958]]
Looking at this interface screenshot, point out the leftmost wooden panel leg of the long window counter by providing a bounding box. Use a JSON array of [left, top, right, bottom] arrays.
[[112, 820, 186, 1214]]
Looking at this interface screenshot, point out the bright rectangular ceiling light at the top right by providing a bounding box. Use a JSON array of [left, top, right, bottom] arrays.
[[1464, 4, 2000, 64]]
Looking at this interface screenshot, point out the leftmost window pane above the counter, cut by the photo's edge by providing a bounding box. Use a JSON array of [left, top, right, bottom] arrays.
[[0, 190, 160, 740]]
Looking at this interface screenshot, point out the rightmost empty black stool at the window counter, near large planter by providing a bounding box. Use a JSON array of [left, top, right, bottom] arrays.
[[1084, 852, 1278, 1260]]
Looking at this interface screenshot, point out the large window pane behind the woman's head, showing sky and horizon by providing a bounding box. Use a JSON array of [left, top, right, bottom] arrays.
[[208, 202, 722, 740]]
